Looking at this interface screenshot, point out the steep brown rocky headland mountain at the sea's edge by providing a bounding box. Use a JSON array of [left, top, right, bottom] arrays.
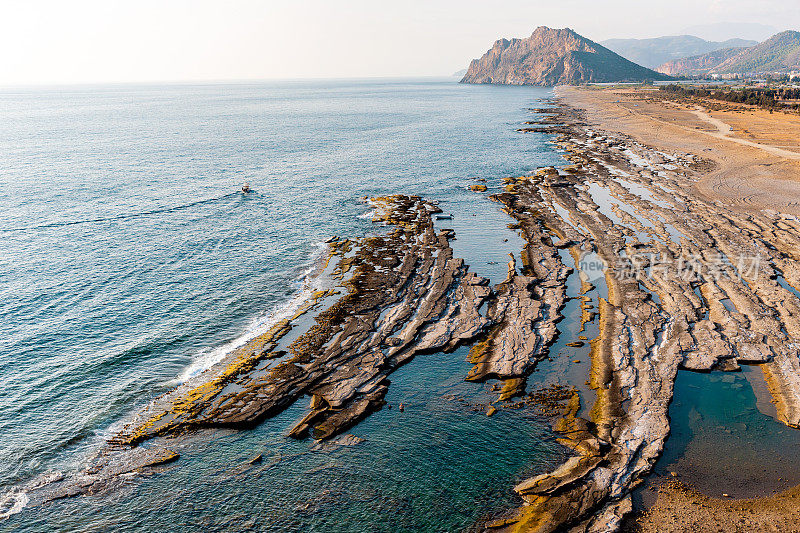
[[461, 26, 667, 86]]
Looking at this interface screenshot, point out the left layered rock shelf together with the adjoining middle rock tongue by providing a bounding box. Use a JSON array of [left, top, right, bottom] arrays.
[[22, 191, 571, 505]]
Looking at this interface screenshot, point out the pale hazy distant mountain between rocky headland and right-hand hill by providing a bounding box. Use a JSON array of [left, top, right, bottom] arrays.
[[600, 35, 758, 68]]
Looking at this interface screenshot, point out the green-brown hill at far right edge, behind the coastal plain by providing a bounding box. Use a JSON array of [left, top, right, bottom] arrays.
[[657, 31, 800, 75]]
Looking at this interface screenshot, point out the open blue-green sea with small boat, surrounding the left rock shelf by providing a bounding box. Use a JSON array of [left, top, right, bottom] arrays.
[[0, 80, 564, 531]]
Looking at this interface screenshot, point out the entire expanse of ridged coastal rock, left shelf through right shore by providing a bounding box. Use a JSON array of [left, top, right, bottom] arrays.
[[17, 102, 800, 532]]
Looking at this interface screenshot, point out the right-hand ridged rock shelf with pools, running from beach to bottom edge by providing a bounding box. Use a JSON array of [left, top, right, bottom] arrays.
[[489, 103, 800, 532]]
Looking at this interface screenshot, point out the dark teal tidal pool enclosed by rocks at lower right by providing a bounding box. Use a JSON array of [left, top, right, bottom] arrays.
[[655, 366, 800, 498]]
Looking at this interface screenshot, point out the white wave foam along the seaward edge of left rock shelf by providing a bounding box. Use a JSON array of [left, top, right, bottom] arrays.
[[169, 243, 328, 385]]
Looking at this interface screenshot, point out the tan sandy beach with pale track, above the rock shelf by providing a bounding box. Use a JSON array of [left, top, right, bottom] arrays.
[[557, 87, 800, 214]]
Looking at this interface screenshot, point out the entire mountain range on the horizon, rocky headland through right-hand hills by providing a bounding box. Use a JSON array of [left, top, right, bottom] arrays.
[[461, 26, 800, 86]]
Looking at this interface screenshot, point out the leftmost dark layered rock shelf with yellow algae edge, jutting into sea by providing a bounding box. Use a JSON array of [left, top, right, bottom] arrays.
[[29, 195, 506, 501]]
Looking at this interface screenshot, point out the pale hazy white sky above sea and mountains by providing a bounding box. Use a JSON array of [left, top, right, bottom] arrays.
[[0, 0, 800, 85]]
